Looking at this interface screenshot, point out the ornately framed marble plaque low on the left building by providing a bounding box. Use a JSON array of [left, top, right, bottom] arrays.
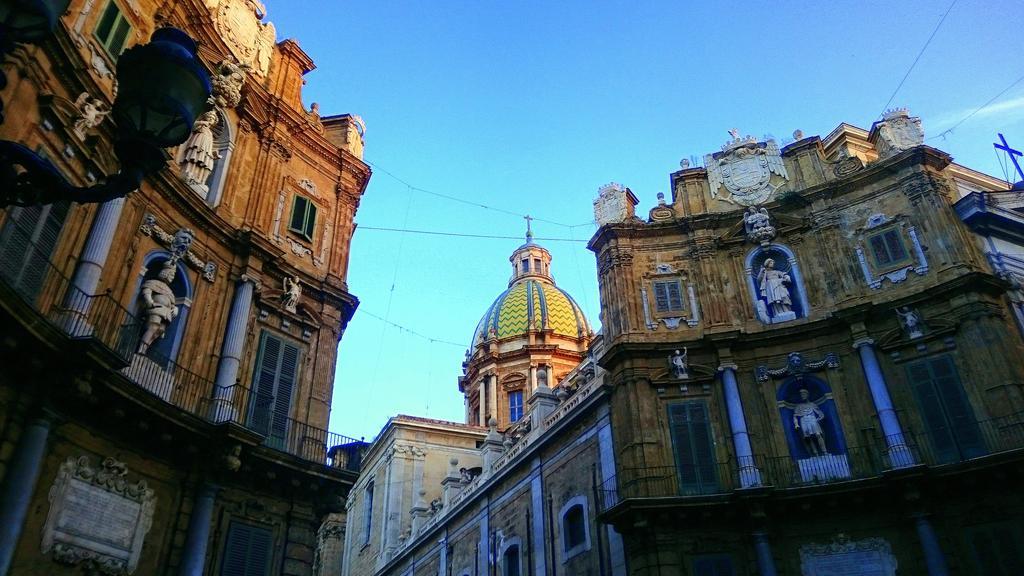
[[42, 456, 156, 576]]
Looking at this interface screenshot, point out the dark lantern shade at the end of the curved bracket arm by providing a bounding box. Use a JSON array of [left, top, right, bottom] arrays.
[[114, 28, 211, 148]]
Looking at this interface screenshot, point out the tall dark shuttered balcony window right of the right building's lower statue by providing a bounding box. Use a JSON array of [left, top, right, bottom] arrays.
[[907, 355, 987, 462]]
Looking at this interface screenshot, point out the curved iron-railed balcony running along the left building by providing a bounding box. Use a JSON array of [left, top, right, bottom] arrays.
[[0, 230, 368, 472]]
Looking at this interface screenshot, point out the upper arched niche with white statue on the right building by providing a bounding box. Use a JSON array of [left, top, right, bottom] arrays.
[[746, 244, 811, 324]]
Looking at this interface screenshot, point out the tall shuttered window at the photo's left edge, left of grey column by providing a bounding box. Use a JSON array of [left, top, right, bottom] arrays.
[[0, 202, 71, 300]]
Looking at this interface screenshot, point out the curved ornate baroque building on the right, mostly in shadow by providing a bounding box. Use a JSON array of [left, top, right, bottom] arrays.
[[590, 111, 1024, 576]]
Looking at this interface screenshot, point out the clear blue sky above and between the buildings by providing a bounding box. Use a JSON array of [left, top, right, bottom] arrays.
[[266, 0, 1024, 438]]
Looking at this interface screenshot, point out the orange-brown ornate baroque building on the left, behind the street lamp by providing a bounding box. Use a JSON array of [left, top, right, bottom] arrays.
[[0, 0, 370, 576]]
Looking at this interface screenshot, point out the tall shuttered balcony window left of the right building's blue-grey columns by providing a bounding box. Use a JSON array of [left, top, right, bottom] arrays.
[[669, 401, 718, 495]]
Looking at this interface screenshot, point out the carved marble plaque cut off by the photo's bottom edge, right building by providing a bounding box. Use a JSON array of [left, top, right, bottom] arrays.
[[800, 535, 896, 576]]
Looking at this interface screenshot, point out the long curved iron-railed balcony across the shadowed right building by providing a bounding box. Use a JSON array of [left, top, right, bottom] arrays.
[[599, 412, 1024, 512]]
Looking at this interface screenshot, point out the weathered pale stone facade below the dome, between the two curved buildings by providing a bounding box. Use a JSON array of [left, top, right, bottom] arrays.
[[343, 338, 626, 576]]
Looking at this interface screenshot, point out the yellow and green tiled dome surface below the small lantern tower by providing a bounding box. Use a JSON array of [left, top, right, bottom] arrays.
[[473, 278, 590, 346]]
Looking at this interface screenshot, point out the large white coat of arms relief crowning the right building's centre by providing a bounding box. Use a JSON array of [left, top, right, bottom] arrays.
[[705, 129, 790, 206]]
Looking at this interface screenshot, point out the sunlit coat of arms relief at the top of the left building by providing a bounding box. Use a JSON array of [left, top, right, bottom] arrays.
[[206, 0, 278, 76]]
